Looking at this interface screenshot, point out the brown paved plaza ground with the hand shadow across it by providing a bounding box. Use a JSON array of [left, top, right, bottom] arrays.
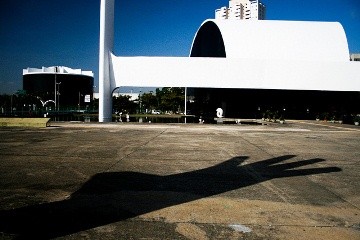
[[0, 122, 360, 240]]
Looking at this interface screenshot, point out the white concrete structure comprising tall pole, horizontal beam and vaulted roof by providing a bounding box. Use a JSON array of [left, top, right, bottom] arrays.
[[99, 0, 360, 122]]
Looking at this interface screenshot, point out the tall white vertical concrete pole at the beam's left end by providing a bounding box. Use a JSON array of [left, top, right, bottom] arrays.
[[99, 0, 115, 122]]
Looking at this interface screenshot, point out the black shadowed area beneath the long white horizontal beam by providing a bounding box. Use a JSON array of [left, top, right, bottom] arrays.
[[188, 88, 360, 122]]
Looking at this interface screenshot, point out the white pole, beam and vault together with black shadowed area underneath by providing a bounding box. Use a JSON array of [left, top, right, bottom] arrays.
[[99, 0, 360, 122]]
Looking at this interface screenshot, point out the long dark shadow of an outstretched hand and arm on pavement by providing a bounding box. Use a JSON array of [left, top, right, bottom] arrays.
[[0, 155, 341, 239]]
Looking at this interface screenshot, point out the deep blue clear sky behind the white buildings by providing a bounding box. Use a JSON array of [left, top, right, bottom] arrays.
[[0, 0, 360, 94]]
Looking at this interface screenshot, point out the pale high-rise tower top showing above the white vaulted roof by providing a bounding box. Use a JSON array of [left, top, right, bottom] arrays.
[[215, 0, 266, 20]]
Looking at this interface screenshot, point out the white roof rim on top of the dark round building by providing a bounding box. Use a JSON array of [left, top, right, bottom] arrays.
[[23, 66, 94, 77]]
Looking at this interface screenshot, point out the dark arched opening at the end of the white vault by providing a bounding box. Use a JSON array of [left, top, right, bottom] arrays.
[[190, 21, 226, 58]]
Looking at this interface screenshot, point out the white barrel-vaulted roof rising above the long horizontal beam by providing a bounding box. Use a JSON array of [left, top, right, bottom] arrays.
[[192, 19, 350, 62]]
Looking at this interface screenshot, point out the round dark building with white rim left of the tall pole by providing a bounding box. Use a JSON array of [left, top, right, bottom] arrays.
[[23, 66, 94, 109]]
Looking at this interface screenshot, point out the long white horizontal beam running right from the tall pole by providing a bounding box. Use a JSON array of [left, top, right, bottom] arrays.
[[112, 55, 360, 91]]
